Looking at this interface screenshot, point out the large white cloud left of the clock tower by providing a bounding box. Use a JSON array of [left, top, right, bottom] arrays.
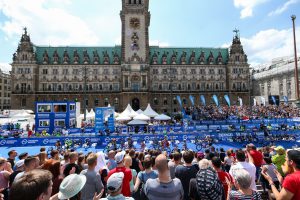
[[0, 0, 120, 46]]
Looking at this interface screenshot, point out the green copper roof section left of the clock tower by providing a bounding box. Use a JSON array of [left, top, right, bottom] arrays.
[[35, 46, 121, 64]]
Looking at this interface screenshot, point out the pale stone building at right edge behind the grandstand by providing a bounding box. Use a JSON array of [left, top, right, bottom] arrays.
[[252, 57, 300, 103]]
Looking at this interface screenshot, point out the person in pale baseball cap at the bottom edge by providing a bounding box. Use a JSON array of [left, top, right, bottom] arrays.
[[101, 172, 134, 200]]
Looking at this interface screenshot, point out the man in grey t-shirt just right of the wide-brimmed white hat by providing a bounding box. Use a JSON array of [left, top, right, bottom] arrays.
[[81, 153, 104, 200]]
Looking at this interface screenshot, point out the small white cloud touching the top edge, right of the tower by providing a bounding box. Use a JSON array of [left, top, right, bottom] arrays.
[[233, 0, 268, 19]]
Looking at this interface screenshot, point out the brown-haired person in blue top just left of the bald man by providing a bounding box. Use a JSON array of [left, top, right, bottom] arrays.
[[134, 157, 158, 200]]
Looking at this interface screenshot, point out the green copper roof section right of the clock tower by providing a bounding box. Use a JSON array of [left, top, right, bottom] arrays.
[[149, 46, 229, 64]]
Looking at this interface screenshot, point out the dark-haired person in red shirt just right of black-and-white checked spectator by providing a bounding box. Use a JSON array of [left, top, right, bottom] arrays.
[[211, 157, 233, 197]]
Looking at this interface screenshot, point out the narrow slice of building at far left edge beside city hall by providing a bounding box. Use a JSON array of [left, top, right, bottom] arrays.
[[0, 69, 11, 111]]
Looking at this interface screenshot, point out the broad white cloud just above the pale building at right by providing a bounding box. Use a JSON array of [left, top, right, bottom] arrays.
[[222, 27, 300, 65]]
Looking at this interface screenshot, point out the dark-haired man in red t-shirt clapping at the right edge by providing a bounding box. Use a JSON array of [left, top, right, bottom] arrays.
[[262, 150, 300, 200]]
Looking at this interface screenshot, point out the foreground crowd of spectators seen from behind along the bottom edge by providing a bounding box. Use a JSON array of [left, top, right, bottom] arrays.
[[0, 144, 300, 200]]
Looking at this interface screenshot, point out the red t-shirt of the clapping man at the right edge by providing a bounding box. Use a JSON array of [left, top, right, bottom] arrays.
[[282, 171, 300, 200]]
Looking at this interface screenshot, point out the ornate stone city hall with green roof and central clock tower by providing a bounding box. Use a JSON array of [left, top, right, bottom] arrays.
[[11, 0, 250, 113]]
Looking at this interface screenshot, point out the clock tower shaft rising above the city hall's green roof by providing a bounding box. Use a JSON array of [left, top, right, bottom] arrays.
[[120, 0, 150, 64]]
